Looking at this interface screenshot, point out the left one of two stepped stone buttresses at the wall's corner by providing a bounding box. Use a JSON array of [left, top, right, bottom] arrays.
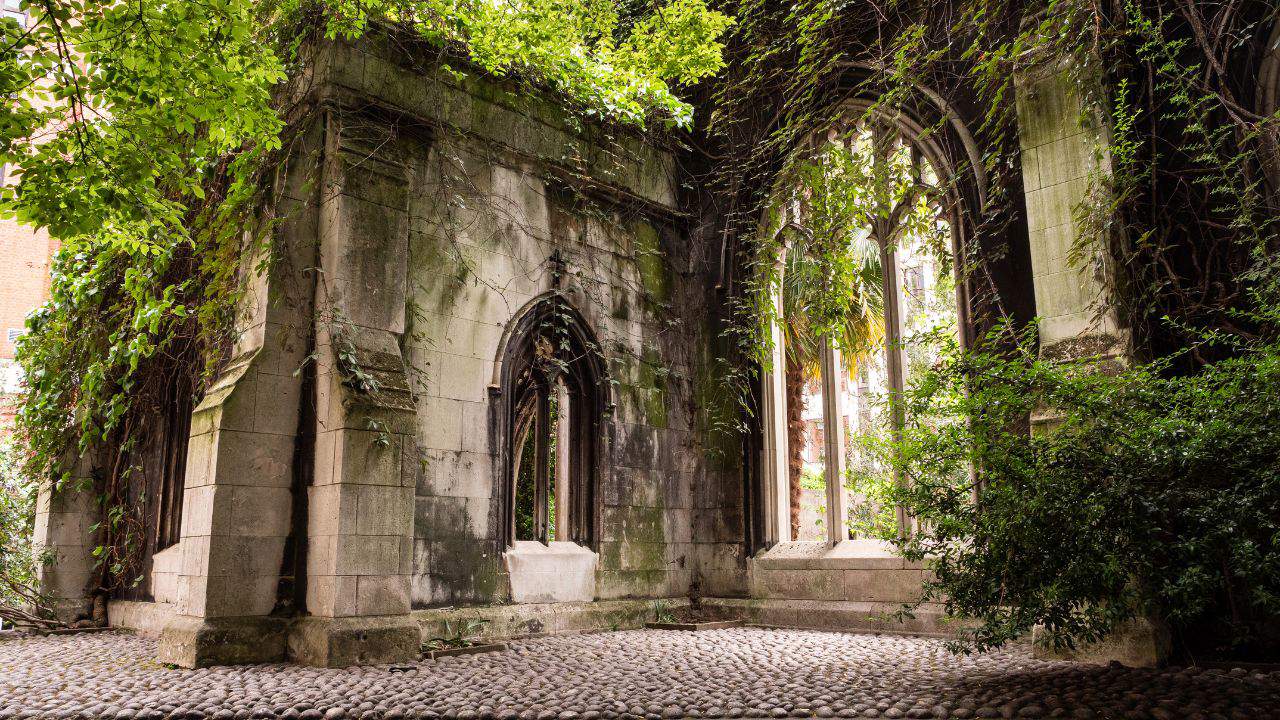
[[159, 142, 315, 667]]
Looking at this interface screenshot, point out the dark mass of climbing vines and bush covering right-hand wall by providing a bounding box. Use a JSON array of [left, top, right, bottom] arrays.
[[707, 0, 1280, 653]]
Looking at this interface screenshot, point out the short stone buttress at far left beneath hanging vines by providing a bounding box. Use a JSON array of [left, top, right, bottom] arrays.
[[32, 450, 101, 621]]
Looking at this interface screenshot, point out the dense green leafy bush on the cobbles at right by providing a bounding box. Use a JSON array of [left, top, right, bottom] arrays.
[[893, 322, 1280, 656]]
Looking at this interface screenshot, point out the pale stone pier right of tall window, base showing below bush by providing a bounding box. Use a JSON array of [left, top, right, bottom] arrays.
[[1015, 57, 1170, 666]]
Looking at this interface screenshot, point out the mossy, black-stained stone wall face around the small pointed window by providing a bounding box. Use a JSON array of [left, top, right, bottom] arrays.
[[309, 36, 741, 607]]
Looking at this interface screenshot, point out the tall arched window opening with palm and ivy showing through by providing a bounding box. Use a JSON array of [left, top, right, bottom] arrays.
[[762, 118, 964, 543]]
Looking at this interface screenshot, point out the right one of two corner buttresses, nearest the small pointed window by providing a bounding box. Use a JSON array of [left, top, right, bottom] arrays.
[[289, 110, 421, 666]]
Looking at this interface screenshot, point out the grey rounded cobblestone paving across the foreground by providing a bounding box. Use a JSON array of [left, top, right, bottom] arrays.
[[0, 628, 1280, 720]]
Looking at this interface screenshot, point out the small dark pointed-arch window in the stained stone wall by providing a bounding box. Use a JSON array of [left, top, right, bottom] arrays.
[[498, 292, 608, 547]]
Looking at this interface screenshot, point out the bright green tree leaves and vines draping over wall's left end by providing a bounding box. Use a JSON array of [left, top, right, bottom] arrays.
[[0, 0, 730, 620]]
